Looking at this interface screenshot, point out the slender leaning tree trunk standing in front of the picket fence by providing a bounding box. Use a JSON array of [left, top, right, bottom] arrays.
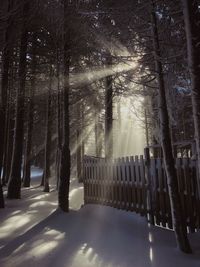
[[151, 0, 191, 253]]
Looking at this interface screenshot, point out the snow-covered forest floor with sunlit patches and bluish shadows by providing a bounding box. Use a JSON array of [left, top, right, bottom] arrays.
[[0, 170, 200, 267]]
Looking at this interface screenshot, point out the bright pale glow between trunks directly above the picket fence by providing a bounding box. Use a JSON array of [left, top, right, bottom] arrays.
[[113, 96, 145, 157]]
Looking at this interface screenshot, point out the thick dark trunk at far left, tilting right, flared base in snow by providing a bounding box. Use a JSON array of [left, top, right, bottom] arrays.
[[7, 3, 29, 199]]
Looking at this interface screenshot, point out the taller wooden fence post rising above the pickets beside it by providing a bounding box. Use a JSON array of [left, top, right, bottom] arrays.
[[144, 147, 155, 225]]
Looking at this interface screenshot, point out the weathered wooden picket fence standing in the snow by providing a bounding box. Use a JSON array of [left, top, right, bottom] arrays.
[[83, 153, 200, 232]]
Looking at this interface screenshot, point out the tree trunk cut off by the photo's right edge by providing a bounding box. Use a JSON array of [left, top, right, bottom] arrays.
[[182, 0, 200, 198]]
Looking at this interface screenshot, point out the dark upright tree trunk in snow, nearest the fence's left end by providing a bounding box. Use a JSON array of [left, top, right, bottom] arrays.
[[58, 0, 71, 212]]
